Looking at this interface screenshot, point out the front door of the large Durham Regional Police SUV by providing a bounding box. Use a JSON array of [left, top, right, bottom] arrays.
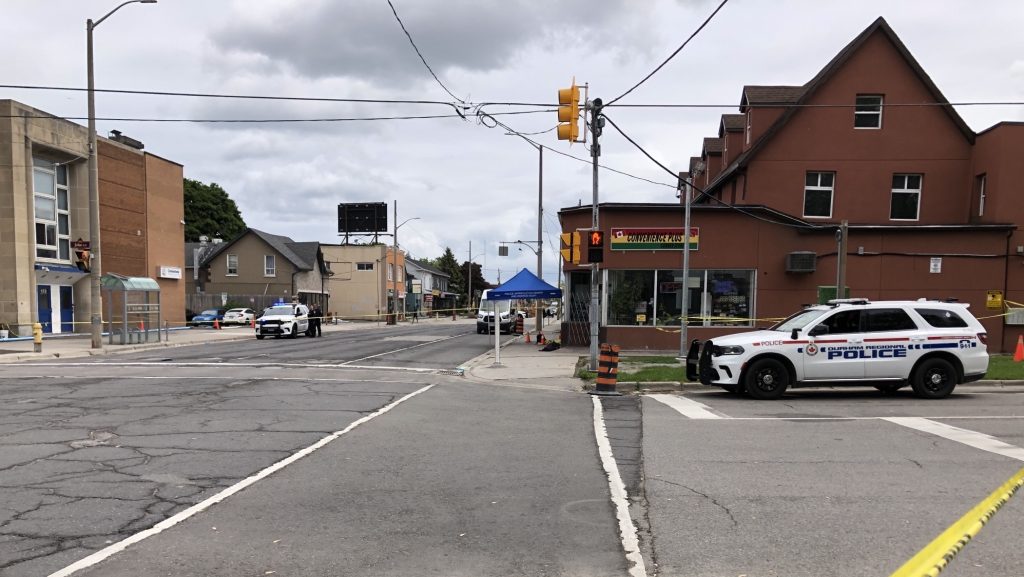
[[804, 307, 864, 380]]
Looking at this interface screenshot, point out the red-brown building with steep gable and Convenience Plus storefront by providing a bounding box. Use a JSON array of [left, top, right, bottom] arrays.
[[560, 18, 1024, 351]]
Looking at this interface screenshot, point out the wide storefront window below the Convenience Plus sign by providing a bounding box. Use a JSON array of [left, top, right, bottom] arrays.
[[608, 270, 755, 327]]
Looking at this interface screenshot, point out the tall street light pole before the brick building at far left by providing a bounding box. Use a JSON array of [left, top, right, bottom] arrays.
[[85, 0, 157, 348]]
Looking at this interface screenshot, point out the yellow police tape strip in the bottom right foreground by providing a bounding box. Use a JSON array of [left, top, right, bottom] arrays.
[[890, 468, 1024, 577]]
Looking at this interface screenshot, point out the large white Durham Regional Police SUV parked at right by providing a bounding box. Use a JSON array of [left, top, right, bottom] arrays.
[[686, 299, 988, 400]]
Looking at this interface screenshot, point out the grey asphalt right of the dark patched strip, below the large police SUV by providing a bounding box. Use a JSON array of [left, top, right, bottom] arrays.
[[630, 387, 1024, 577]]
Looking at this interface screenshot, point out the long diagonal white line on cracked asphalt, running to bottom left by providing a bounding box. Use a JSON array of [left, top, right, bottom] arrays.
[[49, 384, 434, 577]]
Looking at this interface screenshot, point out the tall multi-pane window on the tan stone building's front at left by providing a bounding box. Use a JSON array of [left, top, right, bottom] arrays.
[[32, 158, 71, 261]]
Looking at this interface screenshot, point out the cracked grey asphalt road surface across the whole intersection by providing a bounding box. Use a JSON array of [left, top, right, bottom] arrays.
[[6, 324, 1024, 577]]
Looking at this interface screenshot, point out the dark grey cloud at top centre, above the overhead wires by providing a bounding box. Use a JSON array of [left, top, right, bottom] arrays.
[[211, 0, 640, 87]]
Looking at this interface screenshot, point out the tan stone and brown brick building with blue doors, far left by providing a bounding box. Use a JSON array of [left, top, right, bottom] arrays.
[[0, 99, 184, 335]]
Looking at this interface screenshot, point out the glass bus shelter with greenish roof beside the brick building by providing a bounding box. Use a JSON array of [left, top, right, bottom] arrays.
[[99, 273, 161, 344]]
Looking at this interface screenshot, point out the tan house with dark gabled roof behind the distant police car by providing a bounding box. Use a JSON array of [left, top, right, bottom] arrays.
[[185, 229, 330, 312]]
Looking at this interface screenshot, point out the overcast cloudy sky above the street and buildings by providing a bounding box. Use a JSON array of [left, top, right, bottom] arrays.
[[0, 0, 1024, 282]]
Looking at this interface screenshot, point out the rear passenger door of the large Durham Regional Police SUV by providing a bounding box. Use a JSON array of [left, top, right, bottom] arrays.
[[862, 307, 924, 378]]
